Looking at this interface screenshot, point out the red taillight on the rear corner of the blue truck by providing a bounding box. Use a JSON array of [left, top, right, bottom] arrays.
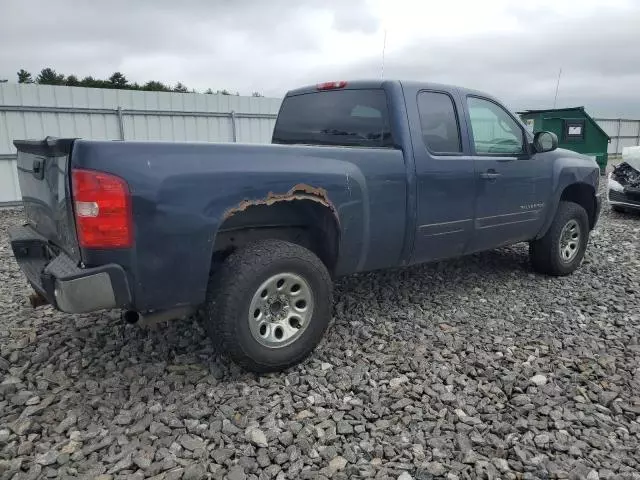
[[71, 169, 133, 248]]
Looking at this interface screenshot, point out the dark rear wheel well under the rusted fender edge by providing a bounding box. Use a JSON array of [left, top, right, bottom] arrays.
[[213, 200, 340, 273]]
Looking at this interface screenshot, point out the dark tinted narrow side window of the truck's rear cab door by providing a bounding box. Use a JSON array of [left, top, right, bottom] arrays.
[[418, 92, 462, 153]]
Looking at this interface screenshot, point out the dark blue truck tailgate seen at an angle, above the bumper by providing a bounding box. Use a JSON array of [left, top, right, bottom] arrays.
[[14, 137, 80, 261]]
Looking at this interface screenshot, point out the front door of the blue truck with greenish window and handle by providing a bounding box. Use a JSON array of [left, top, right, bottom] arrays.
[[465, 95, 552, 253]]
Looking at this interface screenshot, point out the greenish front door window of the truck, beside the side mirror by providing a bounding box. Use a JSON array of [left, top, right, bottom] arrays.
[[467, 97, 524, 155]]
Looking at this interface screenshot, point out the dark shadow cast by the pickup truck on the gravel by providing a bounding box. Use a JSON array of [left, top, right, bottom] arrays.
[[1, 245, 552, 395]]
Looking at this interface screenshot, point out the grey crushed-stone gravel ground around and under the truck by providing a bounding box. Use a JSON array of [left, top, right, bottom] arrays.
[[0, 202, 640, 480]]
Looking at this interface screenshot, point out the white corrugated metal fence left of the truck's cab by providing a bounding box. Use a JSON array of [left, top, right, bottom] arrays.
[[0, 84, 281, 204]]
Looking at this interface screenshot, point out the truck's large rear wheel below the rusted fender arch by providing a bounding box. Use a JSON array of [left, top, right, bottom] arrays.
[[203, 240, 332, 372]]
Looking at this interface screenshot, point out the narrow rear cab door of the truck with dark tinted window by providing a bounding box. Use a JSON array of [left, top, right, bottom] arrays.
[[405, 90, 476, 263]]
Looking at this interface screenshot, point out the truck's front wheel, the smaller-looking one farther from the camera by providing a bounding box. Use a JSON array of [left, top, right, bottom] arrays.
[[529, 201, 589, 276]]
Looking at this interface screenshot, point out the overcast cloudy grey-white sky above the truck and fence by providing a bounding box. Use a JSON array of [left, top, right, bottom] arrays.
[[0, 0, 640, 118]]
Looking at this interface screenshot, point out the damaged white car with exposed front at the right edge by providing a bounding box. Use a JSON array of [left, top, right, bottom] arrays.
[[607, 146, 640, 212]]
